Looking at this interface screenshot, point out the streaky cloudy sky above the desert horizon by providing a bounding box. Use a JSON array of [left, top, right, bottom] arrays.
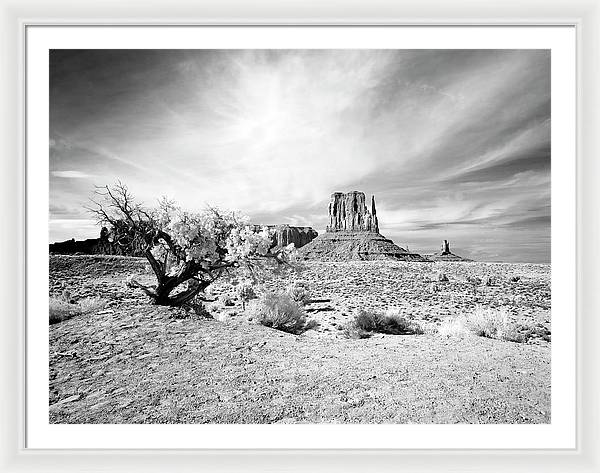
[[49, 49, 551, 263]]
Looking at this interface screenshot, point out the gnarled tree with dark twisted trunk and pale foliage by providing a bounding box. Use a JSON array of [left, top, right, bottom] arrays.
[[87, 182, 290, 306]]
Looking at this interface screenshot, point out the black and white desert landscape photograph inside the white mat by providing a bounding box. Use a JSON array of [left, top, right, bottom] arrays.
[[49, 48, 552, 428]]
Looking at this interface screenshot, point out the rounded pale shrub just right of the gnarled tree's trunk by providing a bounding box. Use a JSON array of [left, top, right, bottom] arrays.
[[251, 292, 306, 334]]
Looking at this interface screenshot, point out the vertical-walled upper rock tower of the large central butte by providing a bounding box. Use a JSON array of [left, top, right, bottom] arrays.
[[327, 191, 379, 233]]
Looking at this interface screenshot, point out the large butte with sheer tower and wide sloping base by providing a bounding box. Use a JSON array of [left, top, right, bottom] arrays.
[[300, 191, 427, 261]]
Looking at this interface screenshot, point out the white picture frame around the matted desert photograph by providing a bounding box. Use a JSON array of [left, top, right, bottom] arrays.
[[0, 0, 600, 471]]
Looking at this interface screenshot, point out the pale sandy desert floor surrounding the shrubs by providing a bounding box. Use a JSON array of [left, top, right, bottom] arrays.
[[49, 255, 550, 423]]
